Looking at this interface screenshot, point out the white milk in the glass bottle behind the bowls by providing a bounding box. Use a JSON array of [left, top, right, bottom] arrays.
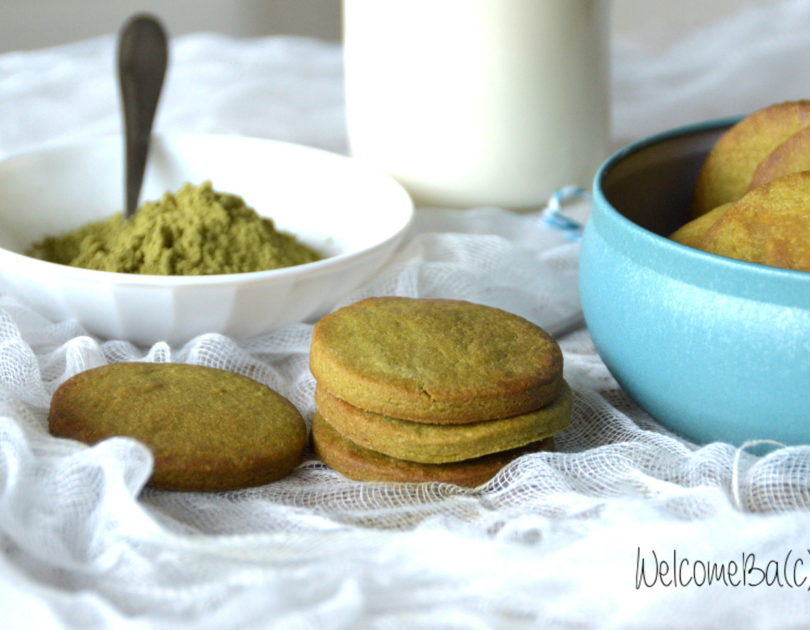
[[343, 0, 609, 208]]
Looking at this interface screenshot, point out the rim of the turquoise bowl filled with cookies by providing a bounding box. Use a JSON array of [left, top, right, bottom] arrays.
[[592, 116, 810, 283]]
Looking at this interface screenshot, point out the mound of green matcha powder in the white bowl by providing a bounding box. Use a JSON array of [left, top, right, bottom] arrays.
[[28, 182, 321, 276]]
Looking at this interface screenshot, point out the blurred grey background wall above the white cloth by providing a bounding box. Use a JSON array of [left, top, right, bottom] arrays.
[[0, 0, 784, 53]]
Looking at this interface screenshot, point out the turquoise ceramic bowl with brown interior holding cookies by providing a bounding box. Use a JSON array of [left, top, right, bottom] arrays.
[[580, 119, 810, 445]]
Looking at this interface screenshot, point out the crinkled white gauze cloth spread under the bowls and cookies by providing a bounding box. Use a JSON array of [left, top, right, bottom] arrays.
[[0, 2, 810, 630]]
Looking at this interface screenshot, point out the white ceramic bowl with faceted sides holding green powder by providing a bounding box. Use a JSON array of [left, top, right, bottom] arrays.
[[0, 134, 413, 345]]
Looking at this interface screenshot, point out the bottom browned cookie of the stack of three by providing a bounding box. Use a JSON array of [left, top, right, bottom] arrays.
[[312, 413, 554, 488]]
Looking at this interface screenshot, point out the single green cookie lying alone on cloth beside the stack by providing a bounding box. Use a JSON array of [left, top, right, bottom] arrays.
[[48, 363, 307, 490]]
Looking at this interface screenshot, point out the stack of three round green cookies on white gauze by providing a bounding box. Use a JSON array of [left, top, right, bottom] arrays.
[[310, 297, 572, 487]]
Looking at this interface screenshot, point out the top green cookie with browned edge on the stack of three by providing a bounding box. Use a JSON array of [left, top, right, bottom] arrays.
[[310, 297, 563, 423]]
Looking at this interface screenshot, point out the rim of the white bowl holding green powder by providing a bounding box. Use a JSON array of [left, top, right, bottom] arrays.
[[0, 136, 415, 287]]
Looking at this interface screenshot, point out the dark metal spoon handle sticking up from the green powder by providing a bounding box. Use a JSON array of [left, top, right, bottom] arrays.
[[118, 14, 168, 218]]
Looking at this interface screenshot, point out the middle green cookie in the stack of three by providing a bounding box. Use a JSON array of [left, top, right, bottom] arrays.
[[315, 383, 572, 464]]
